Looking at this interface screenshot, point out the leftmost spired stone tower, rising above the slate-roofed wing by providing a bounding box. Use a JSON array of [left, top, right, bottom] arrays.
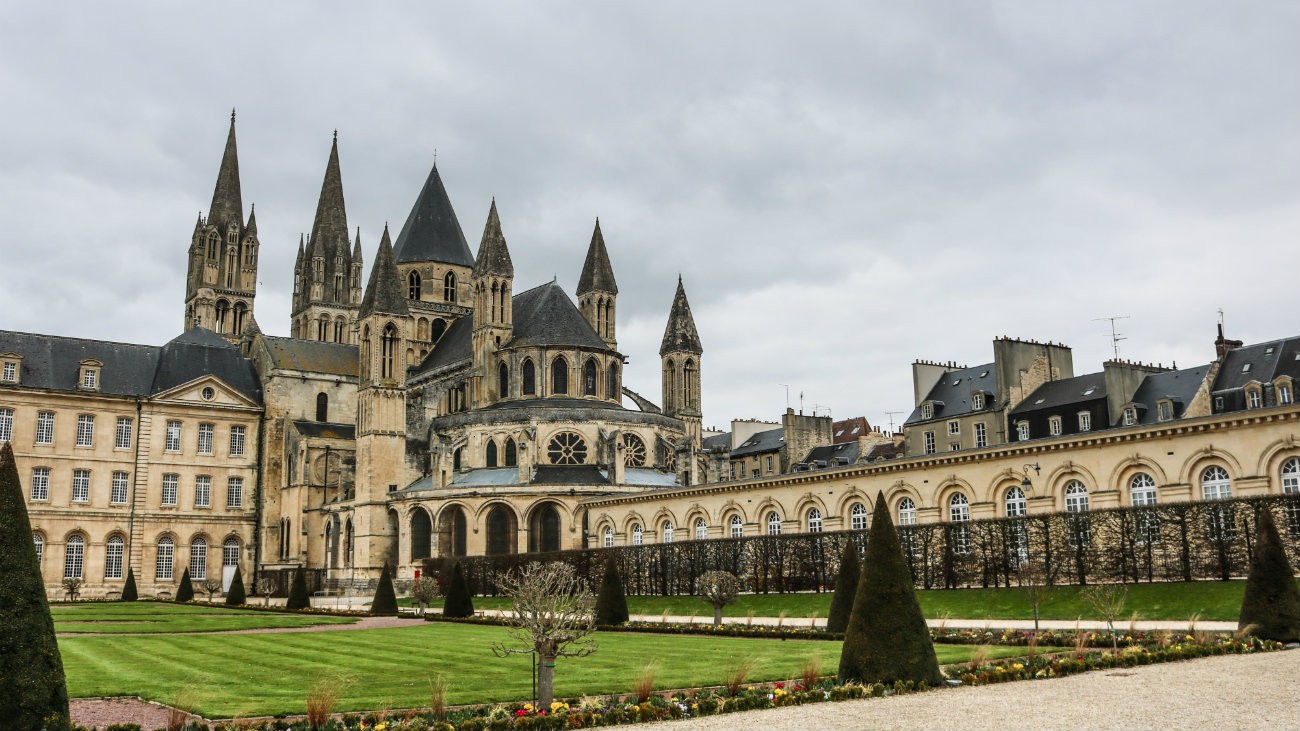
[[185, 111, 259, 343]]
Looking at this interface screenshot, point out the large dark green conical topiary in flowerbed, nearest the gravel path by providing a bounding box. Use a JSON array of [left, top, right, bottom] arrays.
[[840, 494, 944, 685]]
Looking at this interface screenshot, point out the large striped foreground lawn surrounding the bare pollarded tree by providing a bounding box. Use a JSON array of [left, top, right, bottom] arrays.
[[59, 611, 1045, 718]]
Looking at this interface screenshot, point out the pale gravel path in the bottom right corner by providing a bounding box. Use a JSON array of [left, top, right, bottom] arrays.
[[654, 650, 1300, 731]]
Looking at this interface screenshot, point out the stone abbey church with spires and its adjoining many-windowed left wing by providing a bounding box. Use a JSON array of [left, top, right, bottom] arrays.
[[0, 116, 703, 596]]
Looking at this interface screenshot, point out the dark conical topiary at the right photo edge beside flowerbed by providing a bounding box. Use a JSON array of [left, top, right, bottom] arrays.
[[1238, 507, 1300, 643]]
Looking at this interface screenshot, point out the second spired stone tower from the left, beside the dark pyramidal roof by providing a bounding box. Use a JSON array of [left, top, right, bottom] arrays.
[[290, 133, 361, 343]]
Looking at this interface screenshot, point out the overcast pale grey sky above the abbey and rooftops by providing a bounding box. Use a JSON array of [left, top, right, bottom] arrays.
[[0, 0, 1300, 425]]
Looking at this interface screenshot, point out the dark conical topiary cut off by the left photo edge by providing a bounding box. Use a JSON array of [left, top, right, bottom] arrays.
[[0, 442, 68, 730]]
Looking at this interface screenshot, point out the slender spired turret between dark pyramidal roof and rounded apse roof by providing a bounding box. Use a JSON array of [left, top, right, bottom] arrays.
[[469, 199, 515, 407]]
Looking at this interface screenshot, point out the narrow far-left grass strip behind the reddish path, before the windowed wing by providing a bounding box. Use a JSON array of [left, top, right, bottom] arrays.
[[49, 602, 356, 635]]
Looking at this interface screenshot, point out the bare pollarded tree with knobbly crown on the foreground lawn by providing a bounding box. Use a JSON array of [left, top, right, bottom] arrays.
[[491, 561, 595, 708]]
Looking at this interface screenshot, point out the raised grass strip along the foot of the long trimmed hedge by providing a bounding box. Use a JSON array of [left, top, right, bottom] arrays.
[[452, 581, 1263, 616]]
